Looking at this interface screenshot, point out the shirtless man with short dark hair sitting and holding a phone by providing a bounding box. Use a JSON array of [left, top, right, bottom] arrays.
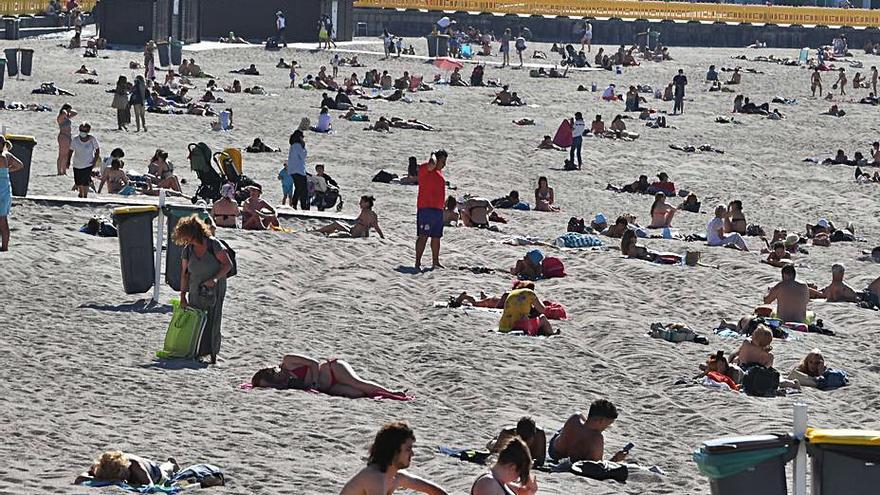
[[547, 399, 627, 462]]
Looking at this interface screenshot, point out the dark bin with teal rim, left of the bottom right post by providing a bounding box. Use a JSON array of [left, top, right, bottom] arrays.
[[693, 435, 797, 495]]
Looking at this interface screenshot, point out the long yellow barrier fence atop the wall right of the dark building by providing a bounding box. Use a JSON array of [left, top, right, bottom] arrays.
[[355, 0, 880, 27]]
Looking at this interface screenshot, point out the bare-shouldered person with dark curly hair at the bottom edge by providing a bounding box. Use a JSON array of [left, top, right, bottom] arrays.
[[339, 423, 448, 495]]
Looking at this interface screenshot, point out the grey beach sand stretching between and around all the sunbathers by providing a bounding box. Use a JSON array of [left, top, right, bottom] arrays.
[[0, 28, 880, 494]]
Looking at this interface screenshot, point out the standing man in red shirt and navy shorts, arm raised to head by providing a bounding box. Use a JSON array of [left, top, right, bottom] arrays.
[[416, 149, 449, 270]]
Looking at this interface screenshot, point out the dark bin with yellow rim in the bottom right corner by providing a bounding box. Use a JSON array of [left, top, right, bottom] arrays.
[[807, 428, 880, 495]]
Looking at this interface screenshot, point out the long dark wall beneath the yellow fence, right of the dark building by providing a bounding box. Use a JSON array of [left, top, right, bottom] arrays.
[[354, 8, 880, 49]]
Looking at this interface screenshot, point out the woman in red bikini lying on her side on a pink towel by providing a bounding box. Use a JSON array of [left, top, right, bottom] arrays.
[[251, 354, 405, 399]]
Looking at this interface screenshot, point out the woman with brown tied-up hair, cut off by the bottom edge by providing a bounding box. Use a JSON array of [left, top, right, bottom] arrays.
[[470, 437, 538, 495]]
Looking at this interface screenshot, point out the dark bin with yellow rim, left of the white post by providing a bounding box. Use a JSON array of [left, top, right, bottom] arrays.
[[113, 206, 159, 294]]
